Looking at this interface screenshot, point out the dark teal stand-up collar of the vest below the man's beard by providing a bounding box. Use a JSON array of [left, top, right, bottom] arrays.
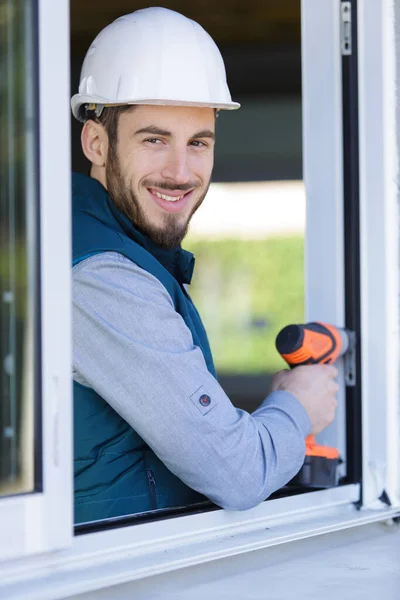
[[72, 173, 195, 284]]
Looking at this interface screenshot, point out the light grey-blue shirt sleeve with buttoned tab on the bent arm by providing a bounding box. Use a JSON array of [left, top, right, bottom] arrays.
[[73, 252, 310, 510]]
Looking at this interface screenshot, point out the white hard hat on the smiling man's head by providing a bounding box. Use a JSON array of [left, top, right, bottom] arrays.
[[71, 7, 240, 120]]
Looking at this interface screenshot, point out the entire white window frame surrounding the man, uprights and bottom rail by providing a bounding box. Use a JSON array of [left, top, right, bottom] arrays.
[[0, 0, 400, 600]]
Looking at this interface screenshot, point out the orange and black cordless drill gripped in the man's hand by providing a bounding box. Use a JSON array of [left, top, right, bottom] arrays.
[[276, 323, 355, 488]]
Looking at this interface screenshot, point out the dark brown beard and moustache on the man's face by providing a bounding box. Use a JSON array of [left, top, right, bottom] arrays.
[[106, 146, 211, 250]]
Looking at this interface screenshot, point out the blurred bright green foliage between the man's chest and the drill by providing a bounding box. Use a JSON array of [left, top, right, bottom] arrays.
[[185, 236, 304, 374]]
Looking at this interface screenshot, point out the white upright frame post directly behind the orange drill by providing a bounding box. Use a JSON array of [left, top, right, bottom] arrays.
[[302, 0, 346, 458]]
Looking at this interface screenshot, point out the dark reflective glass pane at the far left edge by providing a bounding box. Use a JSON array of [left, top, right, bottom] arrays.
[[0, 0, 40, 495]]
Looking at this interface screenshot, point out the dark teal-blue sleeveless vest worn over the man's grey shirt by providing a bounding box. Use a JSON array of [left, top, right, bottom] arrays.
[[72, 174, 215, 523]]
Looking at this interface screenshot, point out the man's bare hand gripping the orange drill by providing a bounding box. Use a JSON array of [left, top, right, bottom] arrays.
[[272, 365, 339, 433]]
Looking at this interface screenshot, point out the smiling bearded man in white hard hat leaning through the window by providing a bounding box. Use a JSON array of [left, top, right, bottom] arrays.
[[72, 8, 338, 523]]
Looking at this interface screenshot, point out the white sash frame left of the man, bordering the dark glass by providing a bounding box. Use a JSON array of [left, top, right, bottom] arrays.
[[0, 1, 73, 564]]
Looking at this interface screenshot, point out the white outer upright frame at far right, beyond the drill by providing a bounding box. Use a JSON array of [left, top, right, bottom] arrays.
[[358, 0, 400, 507]]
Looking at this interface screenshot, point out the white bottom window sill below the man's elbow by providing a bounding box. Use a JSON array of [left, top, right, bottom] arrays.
[[0, 485, 400, 600]]
